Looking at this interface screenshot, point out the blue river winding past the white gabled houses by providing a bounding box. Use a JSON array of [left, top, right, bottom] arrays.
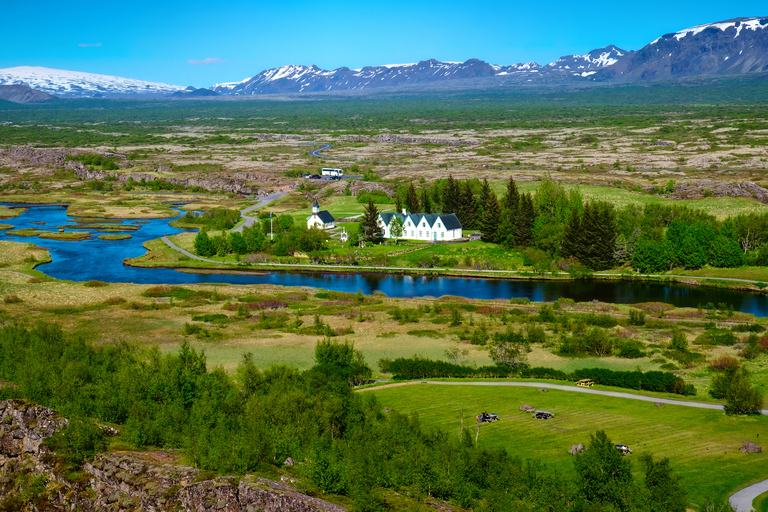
[[0, 207, 768, 316]]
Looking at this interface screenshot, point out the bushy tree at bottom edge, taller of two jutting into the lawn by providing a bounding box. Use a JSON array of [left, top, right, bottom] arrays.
[[574, 430, 632, 510]]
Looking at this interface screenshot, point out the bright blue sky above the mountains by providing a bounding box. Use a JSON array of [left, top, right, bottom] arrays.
[[0, 0, 768, 87]]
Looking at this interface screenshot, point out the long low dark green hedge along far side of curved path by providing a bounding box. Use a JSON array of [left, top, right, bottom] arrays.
[[379, 356, 696, 395]]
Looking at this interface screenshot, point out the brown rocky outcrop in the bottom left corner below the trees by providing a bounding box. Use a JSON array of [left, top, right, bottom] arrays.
[[0, 400, 346, 512]]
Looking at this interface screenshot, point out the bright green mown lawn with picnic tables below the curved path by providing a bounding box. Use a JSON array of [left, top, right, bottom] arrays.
[[371, 384, 768, 505]]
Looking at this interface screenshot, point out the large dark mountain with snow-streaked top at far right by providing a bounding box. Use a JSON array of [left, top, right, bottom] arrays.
[[592, 17, 768, 82]]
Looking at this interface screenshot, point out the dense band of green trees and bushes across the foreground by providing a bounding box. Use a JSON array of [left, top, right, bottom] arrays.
[[0, 323, 687, 512]]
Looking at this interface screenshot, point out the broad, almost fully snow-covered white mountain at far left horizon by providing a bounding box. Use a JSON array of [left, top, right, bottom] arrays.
[[0, 66, 184, 98]]
